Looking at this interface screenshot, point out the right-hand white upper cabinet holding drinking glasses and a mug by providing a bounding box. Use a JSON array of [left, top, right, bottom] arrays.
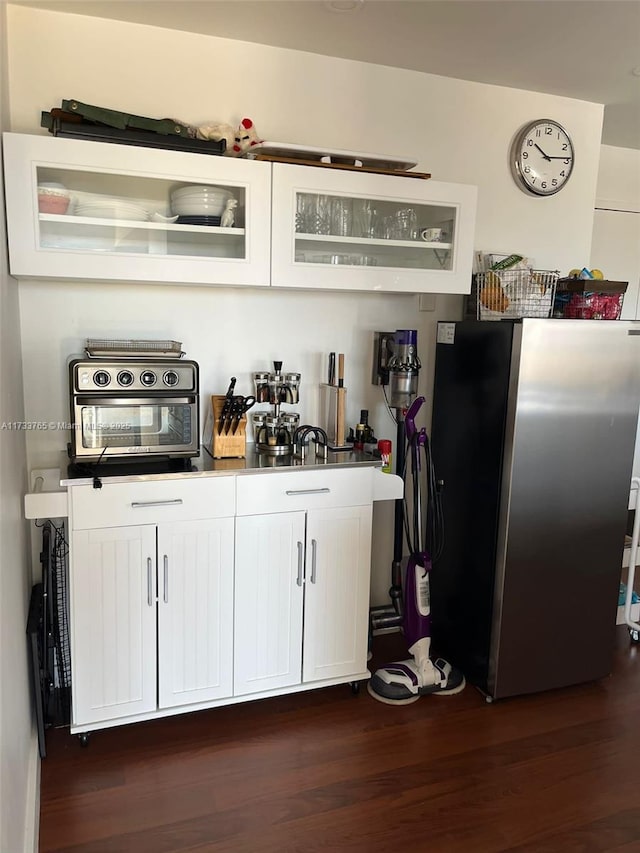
[[271, 164, 477, 293]]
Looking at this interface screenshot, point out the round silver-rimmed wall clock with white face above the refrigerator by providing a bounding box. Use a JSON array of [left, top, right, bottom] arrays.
[[511, 119, 574, 196]]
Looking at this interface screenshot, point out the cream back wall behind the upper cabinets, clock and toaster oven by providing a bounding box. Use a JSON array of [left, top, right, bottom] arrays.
[[3, 6, 602, 602]]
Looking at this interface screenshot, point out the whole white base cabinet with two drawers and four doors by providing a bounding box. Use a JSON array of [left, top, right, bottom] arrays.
[[68, 466, 402, 736]]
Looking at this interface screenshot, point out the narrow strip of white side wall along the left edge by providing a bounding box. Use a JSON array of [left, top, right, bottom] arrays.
[[0, 2, 39, 853]]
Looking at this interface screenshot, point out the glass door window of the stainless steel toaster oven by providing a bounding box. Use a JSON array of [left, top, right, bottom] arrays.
[[75, 398, 198, 455]]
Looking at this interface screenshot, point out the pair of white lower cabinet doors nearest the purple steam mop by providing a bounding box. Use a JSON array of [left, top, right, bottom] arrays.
[[234, 504, 372, 696]]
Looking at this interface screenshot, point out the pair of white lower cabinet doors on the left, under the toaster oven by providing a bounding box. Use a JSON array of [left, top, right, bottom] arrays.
[[71, 516, 233, 726]]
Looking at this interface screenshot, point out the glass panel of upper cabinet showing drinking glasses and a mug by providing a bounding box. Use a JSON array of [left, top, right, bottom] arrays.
[[294, 192, 457, 270]]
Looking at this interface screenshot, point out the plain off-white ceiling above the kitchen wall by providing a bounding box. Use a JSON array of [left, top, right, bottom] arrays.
[[8, 0, 640, 149]]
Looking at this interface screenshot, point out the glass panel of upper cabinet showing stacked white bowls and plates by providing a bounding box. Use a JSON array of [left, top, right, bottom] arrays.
[[35, 166, 247, 260]]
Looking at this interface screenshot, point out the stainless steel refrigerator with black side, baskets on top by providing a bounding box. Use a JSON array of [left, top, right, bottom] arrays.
[[430, 319, 640, 699]]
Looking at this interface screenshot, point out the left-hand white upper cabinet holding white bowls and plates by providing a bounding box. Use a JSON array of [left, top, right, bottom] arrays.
[[3, 133, 271, 286]]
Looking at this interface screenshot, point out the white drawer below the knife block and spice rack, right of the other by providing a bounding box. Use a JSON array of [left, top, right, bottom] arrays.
[[237, 468, 374, 515]]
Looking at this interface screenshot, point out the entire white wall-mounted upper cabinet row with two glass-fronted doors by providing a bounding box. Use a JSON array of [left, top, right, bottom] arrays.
[[3, 133, 476, 293]]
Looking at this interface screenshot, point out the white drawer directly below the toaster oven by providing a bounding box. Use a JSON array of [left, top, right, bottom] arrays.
[[70, 476, 235, 530]]
